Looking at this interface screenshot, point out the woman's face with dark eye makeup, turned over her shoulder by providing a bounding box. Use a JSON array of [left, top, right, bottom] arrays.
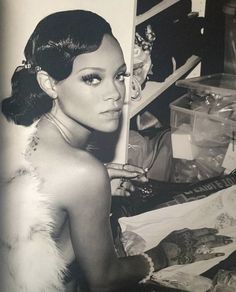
[[56, 35, 126, 132]]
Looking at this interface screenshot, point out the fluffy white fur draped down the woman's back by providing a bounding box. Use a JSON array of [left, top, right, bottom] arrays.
[[0, 114, 66, 292]]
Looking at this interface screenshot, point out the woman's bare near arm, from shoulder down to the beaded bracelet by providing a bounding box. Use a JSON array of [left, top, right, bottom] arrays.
[[60, 159, 154, 292]]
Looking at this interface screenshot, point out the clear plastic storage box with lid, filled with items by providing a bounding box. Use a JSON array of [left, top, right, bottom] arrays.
[[170, 74, 236, 182]]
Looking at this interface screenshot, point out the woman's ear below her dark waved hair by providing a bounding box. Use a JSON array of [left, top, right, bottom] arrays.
[[37, 70, 57, 99]]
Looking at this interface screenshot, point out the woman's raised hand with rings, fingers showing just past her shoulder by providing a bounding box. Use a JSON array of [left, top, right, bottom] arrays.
[[105, 163, 148, 196]]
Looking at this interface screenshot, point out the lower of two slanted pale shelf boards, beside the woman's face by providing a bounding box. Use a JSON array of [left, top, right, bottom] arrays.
[[129, 55, 201, 118]]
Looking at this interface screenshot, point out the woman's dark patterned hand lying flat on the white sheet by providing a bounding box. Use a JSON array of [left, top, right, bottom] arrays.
[[159, 228, 233, 266]]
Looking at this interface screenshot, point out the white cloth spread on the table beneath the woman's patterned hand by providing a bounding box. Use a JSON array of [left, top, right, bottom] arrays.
[[119, 186, 236, 279]]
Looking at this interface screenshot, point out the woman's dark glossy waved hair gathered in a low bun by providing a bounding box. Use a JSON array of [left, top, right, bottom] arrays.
[[2, 10, 113, 126]]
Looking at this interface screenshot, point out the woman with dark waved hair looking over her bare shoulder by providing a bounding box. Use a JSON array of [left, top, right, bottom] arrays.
[[0, 10, 232, 292]]
